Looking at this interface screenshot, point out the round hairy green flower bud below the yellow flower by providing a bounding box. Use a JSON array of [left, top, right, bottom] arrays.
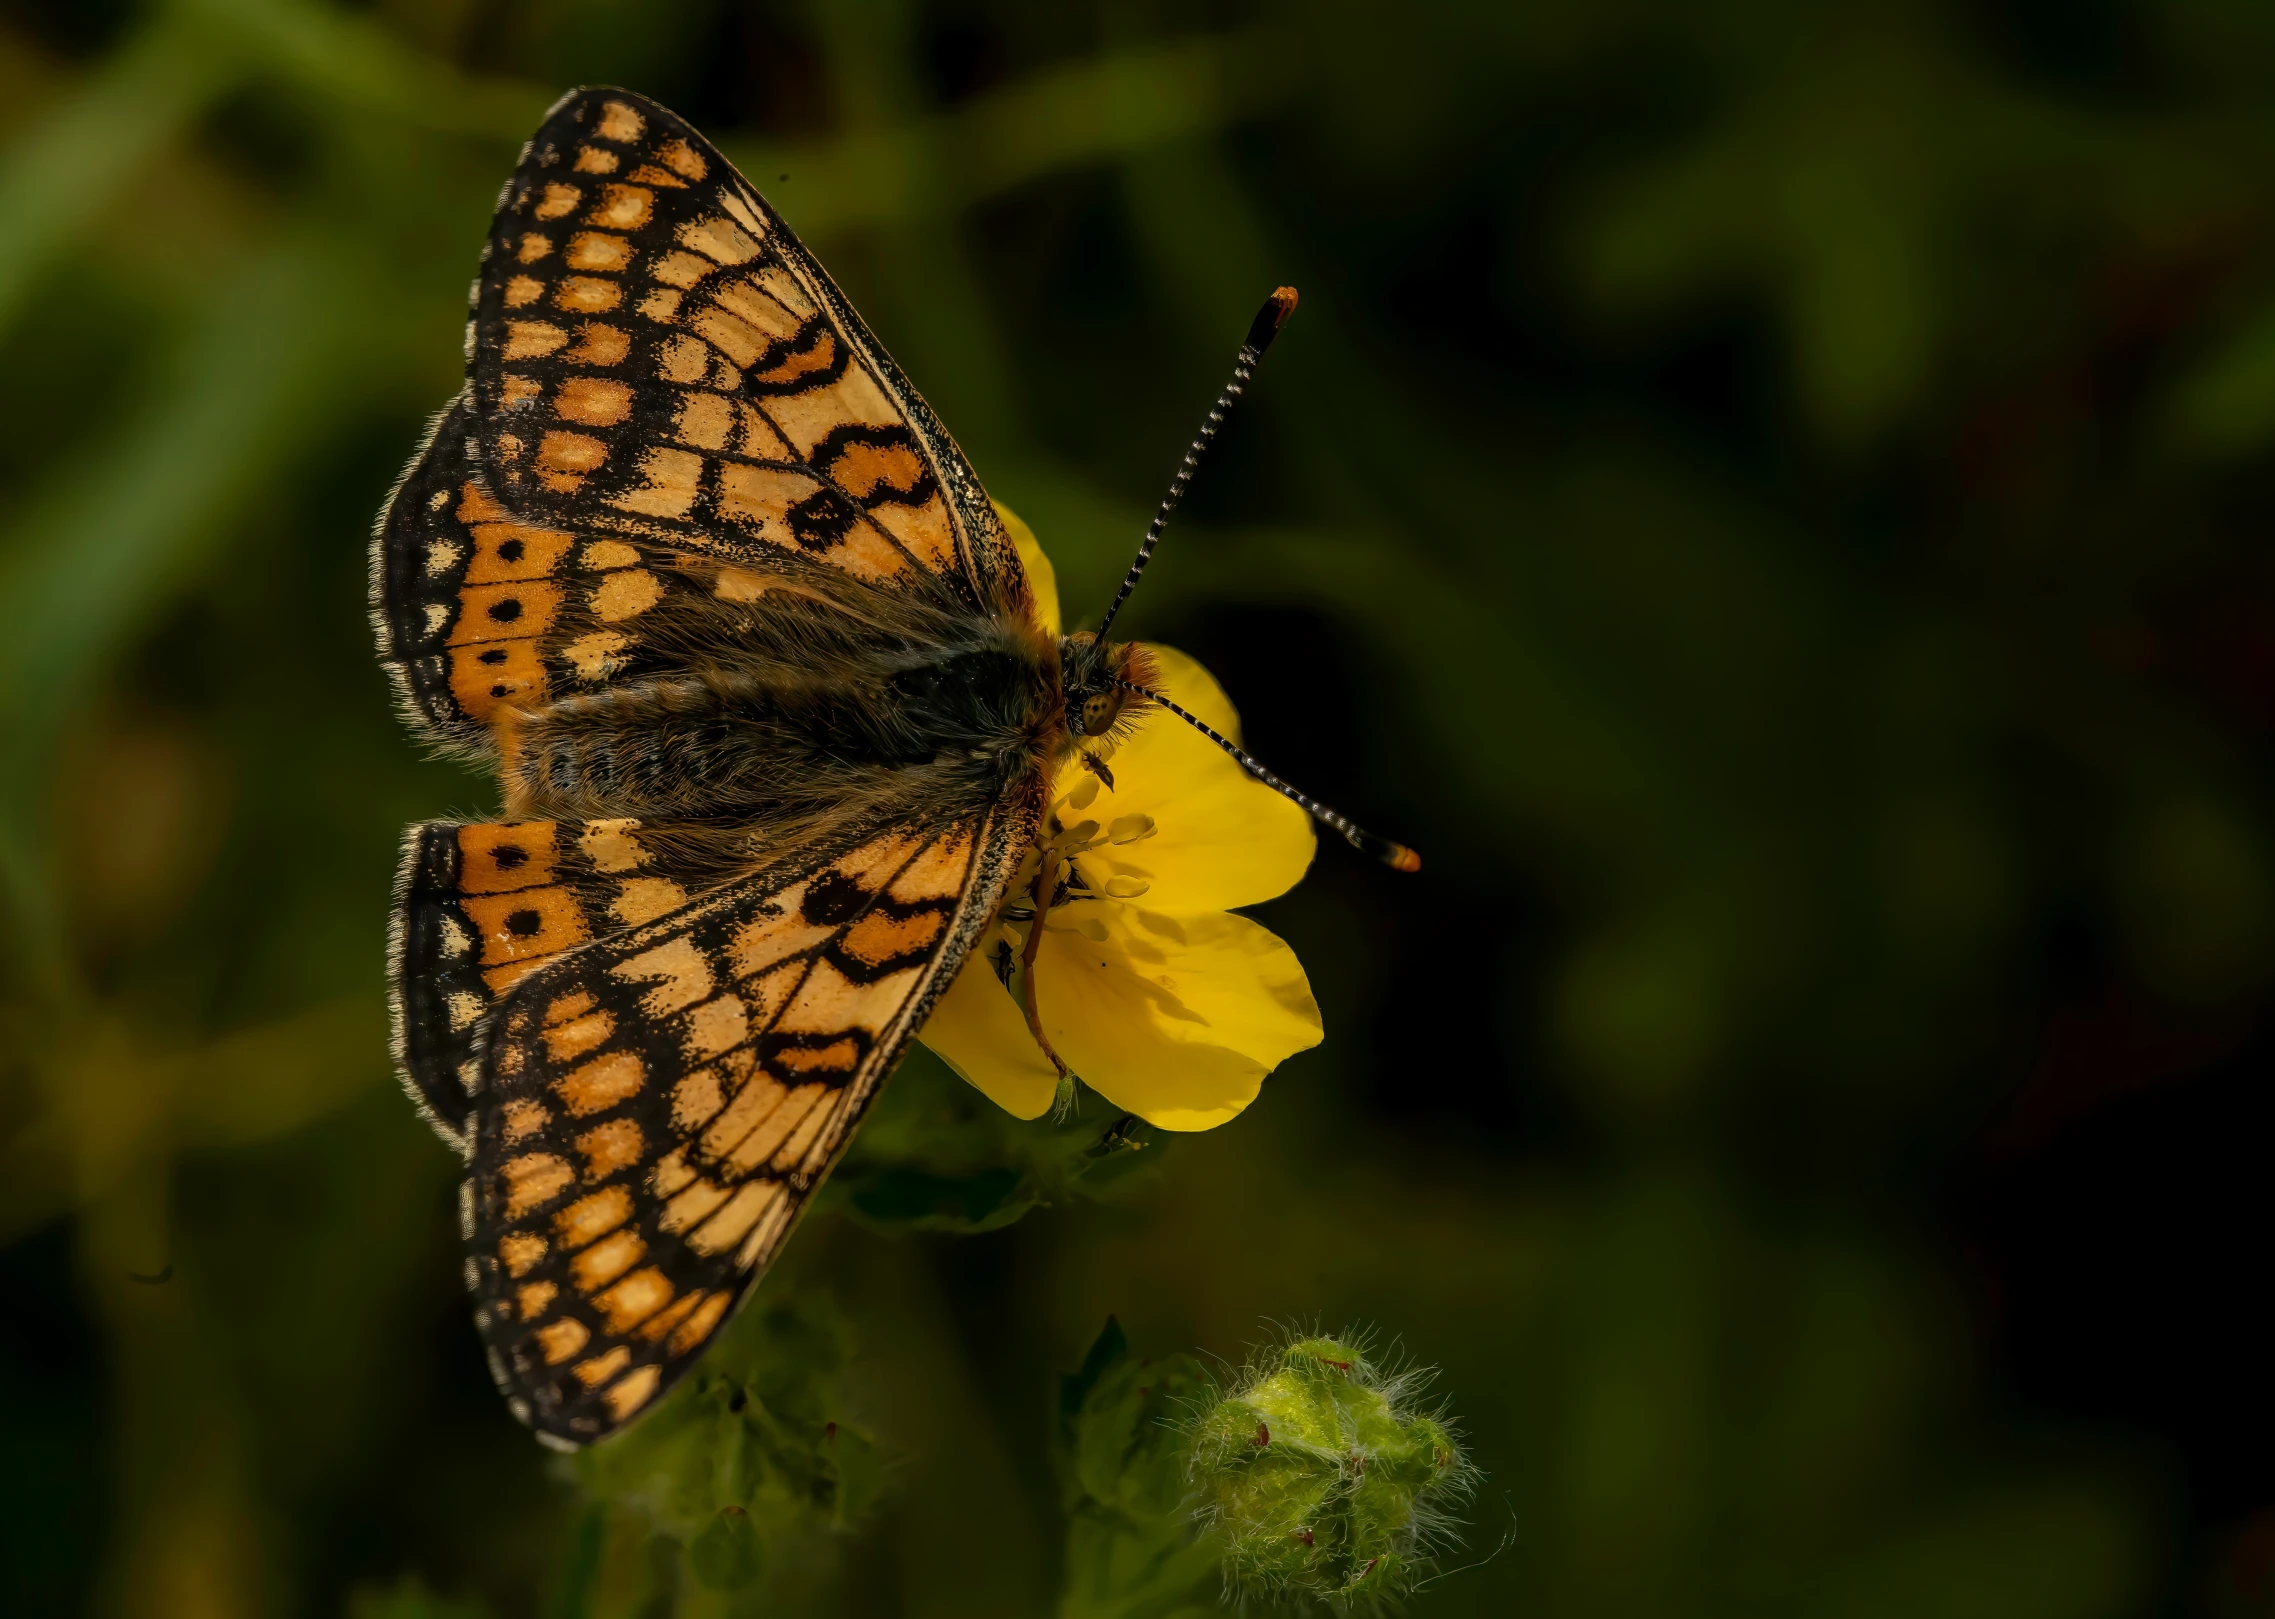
[[1188, 1335, 1474, 1603]]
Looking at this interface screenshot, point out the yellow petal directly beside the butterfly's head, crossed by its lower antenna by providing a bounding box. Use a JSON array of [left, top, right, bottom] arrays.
[[1053, 646, 1320, 923]]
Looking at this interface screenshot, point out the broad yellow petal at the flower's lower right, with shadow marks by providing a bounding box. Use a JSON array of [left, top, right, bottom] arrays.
[[1032, 905, 1320, 1130]]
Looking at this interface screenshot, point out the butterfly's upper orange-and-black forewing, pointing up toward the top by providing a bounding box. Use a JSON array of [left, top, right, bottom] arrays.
[[469, 89, 1021, 607]]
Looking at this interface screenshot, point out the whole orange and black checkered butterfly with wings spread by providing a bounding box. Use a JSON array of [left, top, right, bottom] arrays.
[[371, 89, 1413, 1446]]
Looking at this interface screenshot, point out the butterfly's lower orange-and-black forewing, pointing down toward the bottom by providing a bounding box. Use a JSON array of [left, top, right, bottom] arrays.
[[466, 805, 1033, 1446]]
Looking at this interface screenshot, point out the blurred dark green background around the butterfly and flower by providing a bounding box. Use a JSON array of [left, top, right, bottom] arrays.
[[0, 0, 2275, 1619]]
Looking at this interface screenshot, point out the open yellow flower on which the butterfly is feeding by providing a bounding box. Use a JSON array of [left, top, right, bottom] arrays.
[[919, 507, 1320, 1130]]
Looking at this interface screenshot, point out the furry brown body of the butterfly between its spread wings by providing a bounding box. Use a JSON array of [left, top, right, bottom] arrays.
[[503, 557, 1078, 873]]
